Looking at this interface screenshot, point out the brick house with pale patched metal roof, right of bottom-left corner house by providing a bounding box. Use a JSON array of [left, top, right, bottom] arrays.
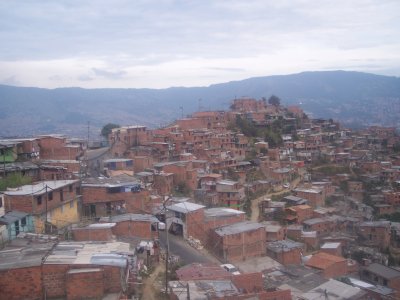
[[42, 242, 133, 299]]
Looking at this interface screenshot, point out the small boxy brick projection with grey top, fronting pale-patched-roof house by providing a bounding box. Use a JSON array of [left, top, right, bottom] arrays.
[[66, 269, 104, 300]]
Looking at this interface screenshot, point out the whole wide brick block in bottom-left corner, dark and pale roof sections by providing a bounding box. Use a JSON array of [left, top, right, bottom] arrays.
[[0, 234, 135, 300]]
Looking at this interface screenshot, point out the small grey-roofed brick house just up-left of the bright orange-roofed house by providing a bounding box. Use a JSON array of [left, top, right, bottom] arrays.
[[267, 240, 304, 265]]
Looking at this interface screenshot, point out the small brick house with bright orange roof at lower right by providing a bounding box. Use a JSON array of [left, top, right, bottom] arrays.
[[306, 252, 347, 278]]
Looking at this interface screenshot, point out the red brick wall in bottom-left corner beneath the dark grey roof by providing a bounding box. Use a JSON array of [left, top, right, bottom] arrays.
[[0, 266, 43, 300]]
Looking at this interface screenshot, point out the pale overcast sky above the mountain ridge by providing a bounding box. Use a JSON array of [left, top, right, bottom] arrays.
[[0, 0, 400, 88]]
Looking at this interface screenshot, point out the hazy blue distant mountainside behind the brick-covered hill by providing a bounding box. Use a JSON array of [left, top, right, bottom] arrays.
[[0, 71, 400, 136]]
